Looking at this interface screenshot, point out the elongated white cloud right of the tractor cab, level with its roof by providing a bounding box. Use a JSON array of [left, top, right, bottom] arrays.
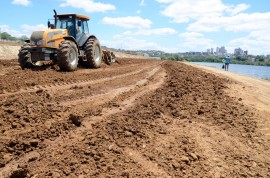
[[102, 16, 152, 29]]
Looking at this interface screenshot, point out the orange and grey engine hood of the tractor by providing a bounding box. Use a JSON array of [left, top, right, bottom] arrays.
[[30, 29, 68, 48]]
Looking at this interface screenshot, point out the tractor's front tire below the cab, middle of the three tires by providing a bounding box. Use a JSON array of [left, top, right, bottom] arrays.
[[57, 40, 79, 71]]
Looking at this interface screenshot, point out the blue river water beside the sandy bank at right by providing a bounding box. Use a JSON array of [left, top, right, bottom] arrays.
[[192, 62, 270, 79]]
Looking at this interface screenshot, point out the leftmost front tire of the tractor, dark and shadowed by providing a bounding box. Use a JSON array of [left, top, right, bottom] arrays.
[[18, 44, 33, 69]]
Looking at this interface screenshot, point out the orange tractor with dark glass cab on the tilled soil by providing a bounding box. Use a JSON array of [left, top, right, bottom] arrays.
[[18, 10, 102, 71]]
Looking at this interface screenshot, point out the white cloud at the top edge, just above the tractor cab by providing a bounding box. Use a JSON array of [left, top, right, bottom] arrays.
[[60, 0, 116, 13]]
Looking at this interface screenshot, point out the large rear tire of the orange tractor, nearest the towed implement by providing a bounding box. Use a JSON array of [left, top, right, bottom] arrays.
[[85, 38, 102, 68]]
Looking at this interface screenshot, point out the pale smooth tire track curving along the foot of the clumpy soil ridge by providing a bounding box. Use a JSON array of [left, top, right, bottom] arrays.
[[0, 63, 166, 177]]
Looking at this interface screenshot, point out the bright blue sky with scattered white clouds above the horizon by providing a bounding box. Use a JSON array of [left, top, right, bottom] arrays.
[[0, 0, 270, 55]]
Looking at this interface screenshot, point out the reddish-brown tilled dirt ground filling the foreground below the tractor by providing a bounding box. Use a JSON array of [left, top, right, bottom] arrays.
[[0, 59, 270, 178]]
